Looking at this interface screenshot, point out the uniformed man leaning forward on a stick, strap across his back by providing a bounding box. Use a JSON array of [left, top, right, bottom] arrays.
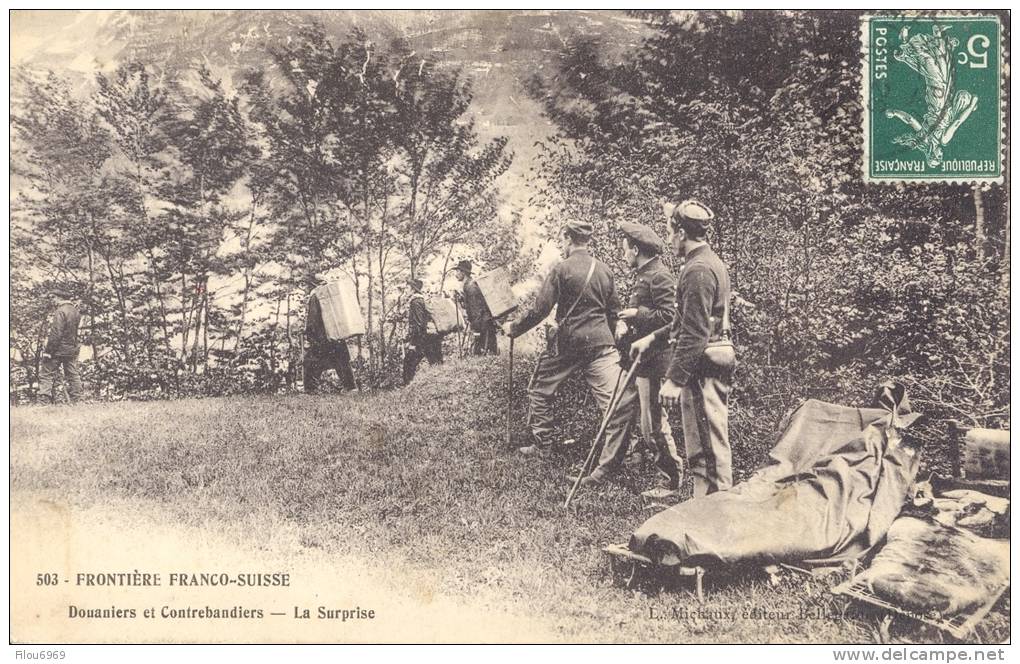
[[503, 221, 638, 484]]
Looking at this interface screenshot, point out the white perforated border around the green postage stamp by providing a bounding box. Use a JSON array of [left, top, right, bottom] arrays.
[[860, 12, 1008, 186]]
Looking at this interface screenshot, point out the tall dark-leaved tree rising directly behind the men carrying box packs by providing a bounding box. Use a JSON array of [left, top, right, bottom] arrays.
[[246, 28, 510, 373]]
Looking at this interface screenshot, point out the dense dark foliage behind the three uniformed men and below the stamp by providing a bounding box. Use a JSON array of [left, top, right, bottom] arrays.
[[530, 11, 1009, 466]]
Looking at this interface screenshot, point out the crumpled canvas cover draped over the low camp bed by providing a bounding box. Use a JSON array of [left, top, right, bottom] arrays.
[[629, 385, 919, 565]]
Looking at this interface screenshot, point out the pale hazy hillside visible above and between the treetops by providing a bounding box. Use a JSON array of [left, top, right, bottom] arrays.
[[11, 10, 648, 204]]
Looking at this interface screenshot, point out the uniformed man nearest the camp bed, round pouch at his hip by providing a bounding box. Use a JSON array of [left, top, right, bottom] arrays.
[[631, 200, 736, 496]]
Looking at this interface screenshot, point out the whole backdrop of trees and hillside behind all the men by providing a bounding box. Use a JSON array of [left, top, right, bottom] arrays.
[[10, 11, 1010, 463]]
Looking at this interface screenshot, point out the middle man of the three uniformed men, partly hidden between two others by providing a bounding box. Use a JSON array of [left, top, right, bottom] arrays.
[[616, 221, 683, 491]]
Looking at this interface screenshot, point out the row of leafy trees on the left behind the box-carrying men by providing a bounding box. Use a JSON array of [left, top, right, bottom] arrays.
[[12, 25, 525, 398]]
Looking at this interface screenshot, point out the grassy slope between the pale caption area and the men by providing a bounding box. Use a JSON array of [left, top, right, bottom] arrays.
[[11, 359, 1009, 643]]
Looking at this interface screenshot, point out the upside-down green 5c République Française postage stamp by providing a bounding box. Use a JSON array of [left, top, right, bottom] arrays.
[[861, 15, 1003, 183]]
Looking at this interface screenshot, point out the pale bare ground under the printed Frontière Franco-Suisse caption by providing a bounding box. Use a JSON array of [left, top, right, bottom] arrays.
[[10, 491, 562, 643]]
